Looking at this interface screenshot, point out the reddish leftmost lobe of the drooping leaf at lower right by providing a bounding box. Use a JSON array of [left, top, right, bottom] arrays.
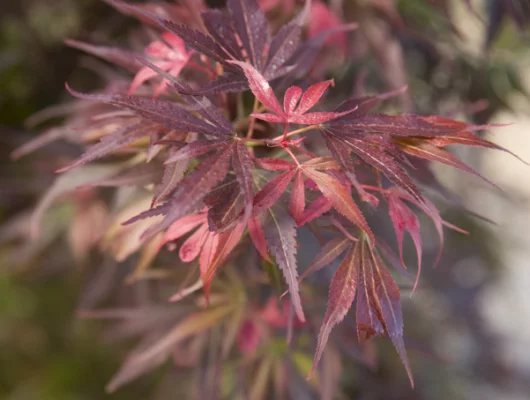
[[308, 242, 363, 379]]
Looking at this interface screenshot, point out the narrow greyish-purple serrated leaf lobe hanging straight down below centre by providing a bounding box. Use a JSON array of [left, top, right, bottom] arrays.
[[264, 208, 305, 322]]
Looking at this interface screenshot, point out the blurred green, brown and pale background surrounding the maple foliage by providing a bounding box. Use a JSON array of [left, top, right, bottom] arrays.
[[0, 0, 530, 400]]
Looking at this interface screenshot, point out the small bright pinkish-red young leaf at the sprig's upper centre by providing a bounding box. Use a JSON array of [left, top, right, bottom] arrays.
[[230, 61, 356, 125]]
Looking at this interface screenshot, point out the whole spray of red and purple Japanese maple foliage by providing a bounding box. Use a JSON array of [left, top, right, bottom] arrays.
[[16, 0, 524, 396]]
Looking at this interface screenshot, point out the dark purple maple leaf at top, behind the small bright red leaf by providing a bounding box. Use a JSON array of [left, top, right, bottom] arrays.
[[103, 0, 323, 94]]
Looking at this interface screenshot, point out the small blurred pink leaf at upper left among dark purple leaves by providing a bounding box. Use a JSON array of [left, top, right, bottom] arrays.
[[129, 32, 193, 97]]
